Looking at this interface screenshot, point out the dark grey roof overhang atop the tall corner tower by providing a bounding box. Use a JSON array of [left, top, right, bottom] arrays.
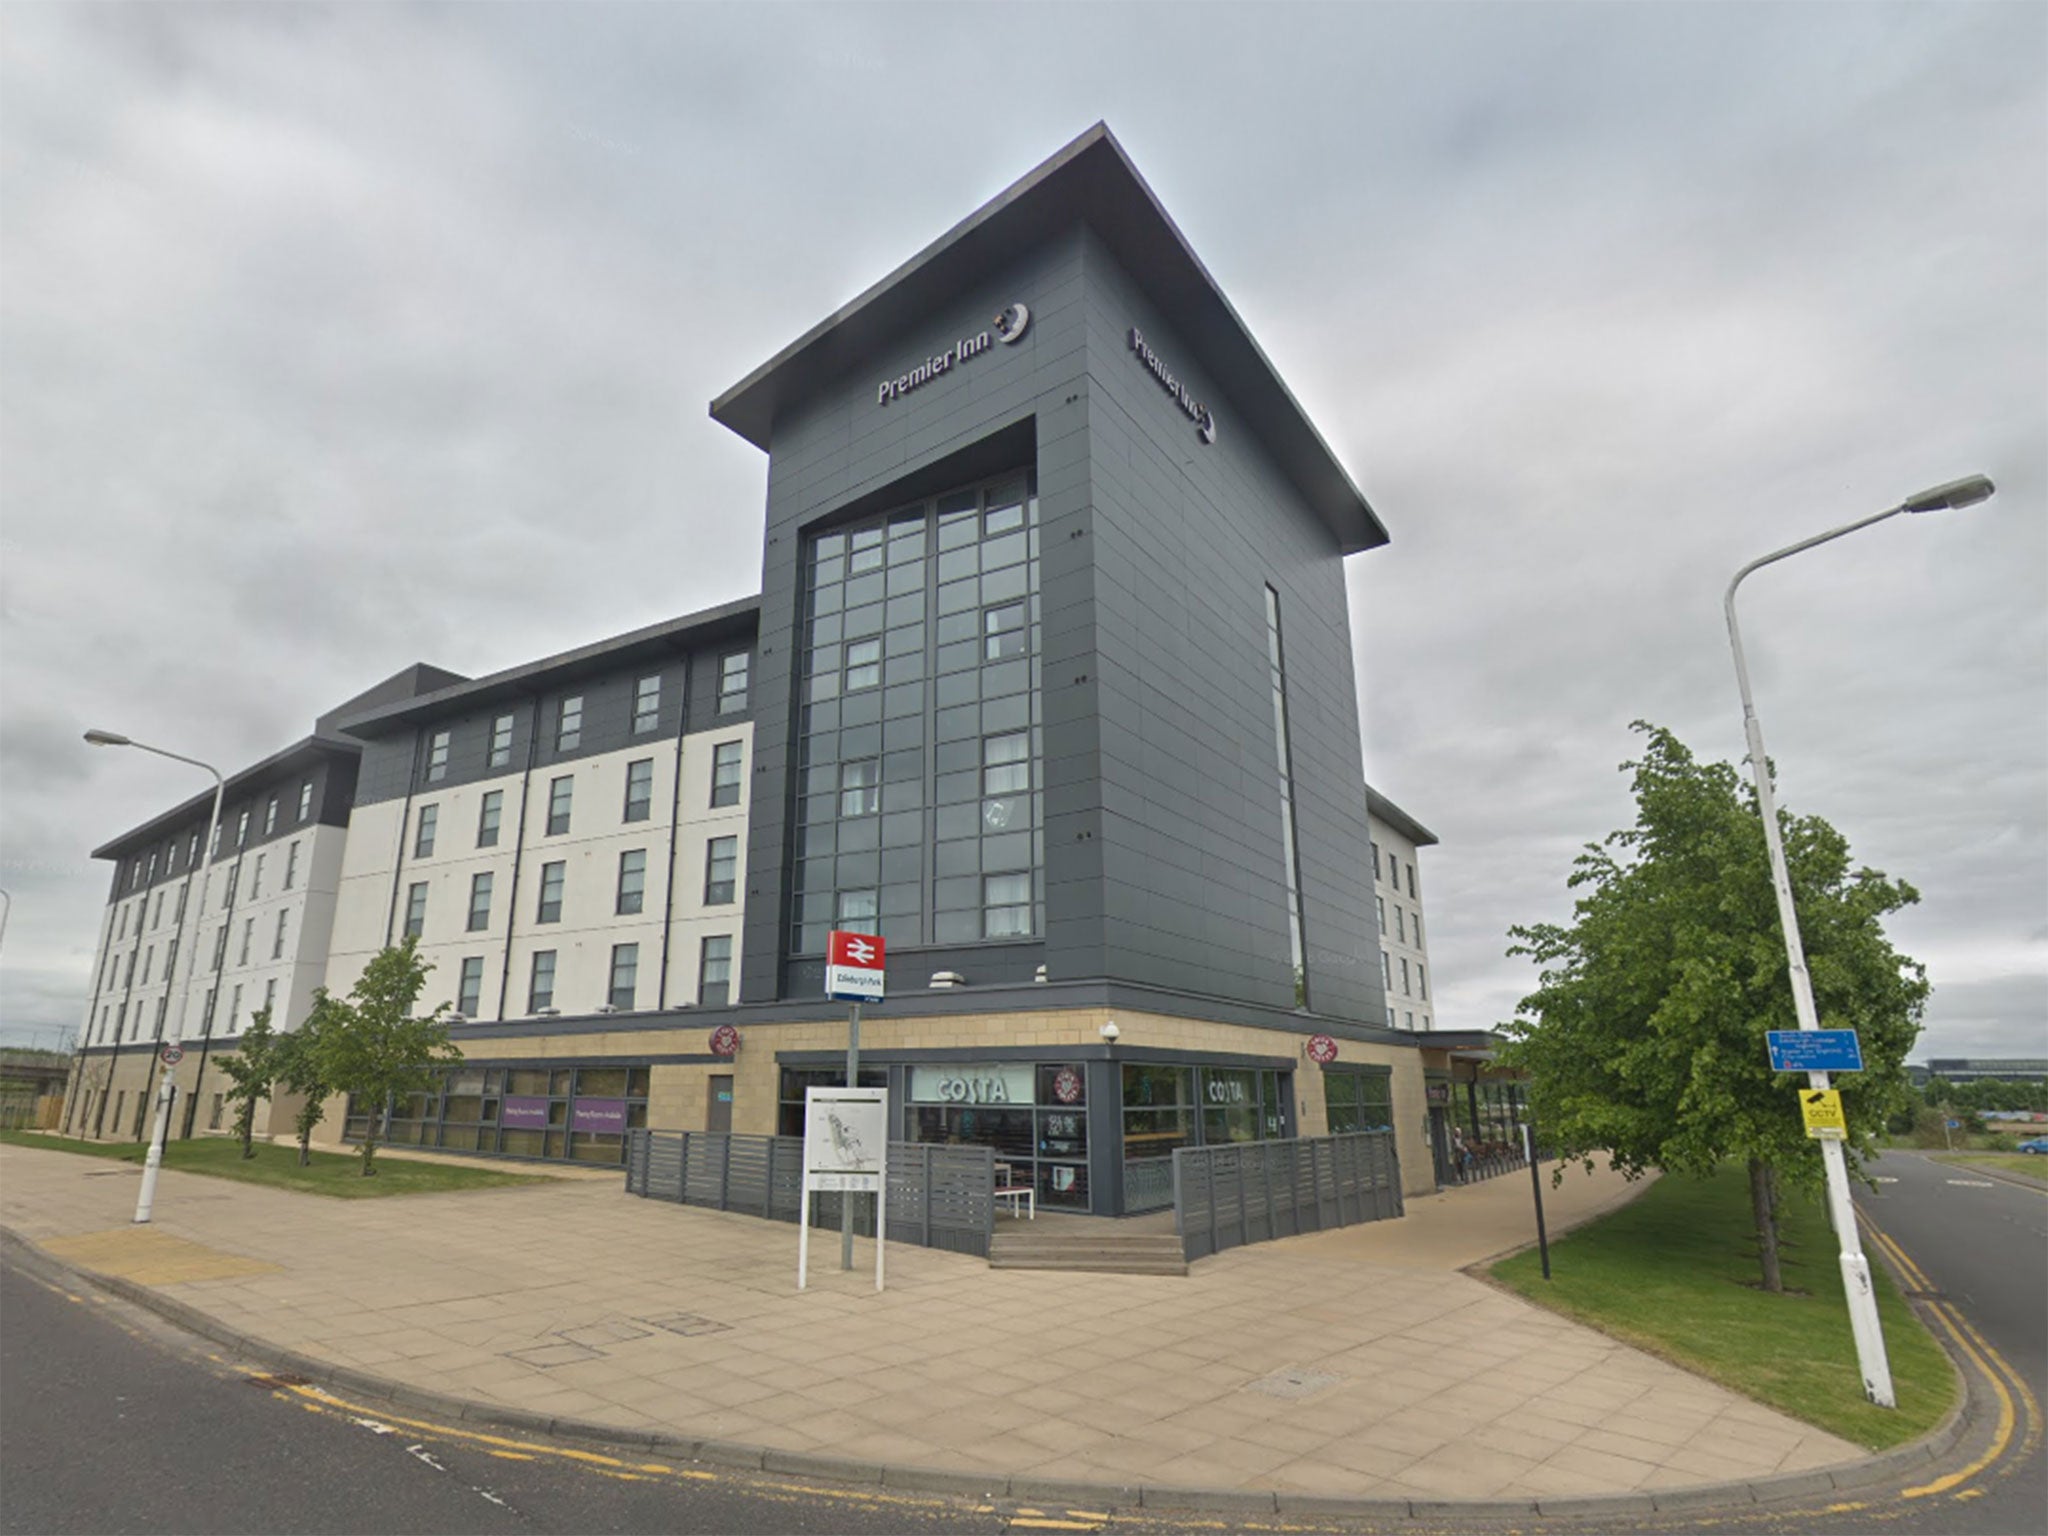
[[711, 123, 1386, 555]]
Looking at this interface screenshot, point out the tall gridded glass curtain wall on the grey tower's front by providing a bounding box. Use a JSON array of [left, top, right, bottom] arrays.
[[788, 471, 1044, 954]]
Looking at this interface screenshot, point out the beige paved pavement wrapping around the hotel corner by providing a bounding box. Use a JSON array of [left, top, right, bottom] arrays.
[[0, 1147, 1900, 1513]]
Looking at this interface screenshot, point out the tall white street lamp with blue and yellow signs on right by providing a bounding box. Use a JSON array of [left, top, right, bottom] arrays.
[[1722, 475, 1997, 1407]]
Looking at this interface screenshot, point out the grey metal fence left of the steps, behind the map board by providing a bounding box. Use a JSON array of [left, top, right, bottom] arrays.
[[627, 1130, 995, 1257]]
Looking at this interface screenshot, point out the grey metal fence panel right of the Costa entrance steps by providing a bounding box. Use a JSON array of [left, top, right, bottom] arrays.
[[1174, 1130, 1403, 1260]]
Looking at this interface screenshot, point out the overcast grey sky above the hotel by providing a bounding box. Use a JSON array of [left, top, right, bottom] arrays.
[[0, 2, 2048, 1057]]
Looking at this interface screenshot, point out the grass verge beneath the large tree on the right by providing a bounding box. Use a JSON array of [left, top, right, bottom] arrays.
[[1493, 1167, 1958, 1450]]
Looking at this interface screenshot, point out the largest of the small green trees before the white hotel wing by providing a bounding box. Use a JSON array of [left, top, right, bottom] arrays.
[[319, 936, 463, 1178]]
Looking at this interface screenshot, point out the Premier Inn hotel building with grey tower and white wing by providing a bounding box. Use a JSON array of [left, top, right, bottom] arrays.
[[72, 125, 1479, 1214]]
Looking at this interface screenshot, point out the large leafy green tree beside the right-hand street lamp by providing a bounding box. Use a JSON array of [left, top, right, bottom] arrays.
[[1501, 721, 1927, 1290]]
